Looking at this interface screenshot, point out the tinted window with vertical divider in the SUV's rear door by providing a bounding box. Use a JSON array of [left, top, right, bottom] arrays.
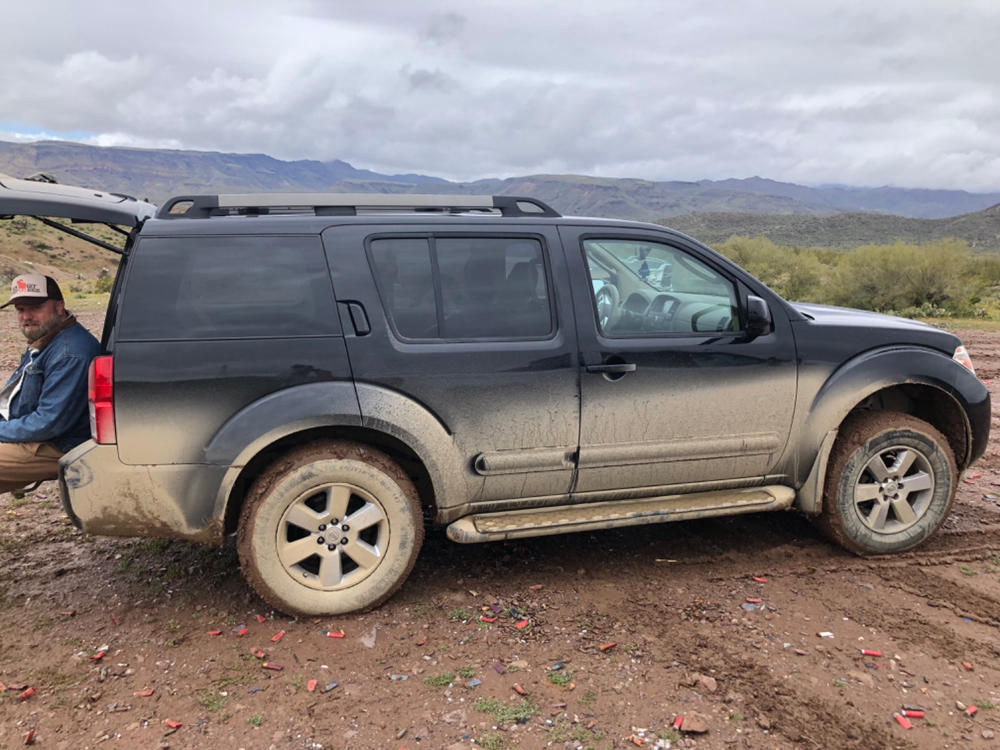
[[369, 237, 552, 340]]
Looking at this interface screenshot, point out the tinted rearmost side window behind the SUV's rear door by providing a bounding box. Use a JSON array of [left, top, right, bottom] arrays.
[[119, 236, 340, 340]]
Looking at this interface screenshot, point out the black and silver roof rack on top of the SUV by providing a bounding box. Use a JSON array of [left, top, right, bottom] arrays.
[[156, 193, 560, 219]]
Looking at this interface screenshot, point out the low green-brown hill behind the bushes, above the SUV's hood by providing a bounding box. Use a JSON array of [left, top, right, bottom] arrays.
[[661, 205, 1000, 252]]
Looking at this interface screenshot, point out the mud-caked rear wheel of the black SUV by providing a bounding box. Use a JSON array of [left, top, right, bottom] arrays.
[[236, 440, 424, 615]]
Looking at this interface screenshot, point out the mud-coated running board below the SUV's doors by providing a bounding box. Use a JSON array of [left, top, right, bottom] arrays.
[[448, 485, 795, 544]]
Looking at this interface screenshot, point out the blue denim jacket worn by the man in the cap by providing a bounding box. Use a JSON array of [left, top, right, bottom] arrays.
[[0, 319, 101, 453]]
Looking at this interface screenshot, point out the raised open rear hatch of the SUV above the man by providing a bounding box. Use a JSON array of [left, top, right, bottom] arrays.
[[0, 174, 156, 253]]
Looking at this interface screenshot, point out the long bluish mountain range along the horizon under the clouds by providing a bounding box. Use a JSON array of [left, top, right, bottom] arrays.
[[0, 141, 1000, 221]]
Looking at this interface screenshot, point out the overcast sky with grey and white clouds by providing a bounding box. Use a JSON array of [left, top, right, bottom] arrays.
[[0, 0, 1000, 191]]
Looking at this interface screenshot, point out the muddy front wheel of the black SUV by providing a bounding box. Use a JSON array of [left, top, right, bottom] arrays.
[[818, 412, 958, 555]]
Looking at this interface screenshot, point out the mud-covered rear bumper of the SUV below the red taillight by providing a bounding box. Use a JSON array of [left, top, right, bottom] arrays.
[[59, 440, 229, 544]]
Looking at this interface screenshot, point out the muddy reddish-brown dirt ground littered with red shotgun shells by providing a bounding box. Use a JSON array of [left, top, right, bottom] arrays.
[[0, 313, 1000, 750]]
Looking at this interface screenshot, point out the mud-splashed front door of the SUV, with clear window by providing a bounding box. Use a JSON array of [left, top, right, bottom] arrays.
[[560, 226, 796, 499]]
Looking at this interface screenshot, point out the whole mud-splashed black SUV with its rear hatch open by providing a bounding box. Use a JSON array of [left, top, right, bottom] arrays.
[[0, 178, 990, 614]]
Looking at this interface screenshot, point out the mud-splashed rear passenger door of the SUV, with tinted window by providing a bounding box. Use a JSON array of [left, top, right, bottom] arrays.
[[323, 219, 579, 507]]
